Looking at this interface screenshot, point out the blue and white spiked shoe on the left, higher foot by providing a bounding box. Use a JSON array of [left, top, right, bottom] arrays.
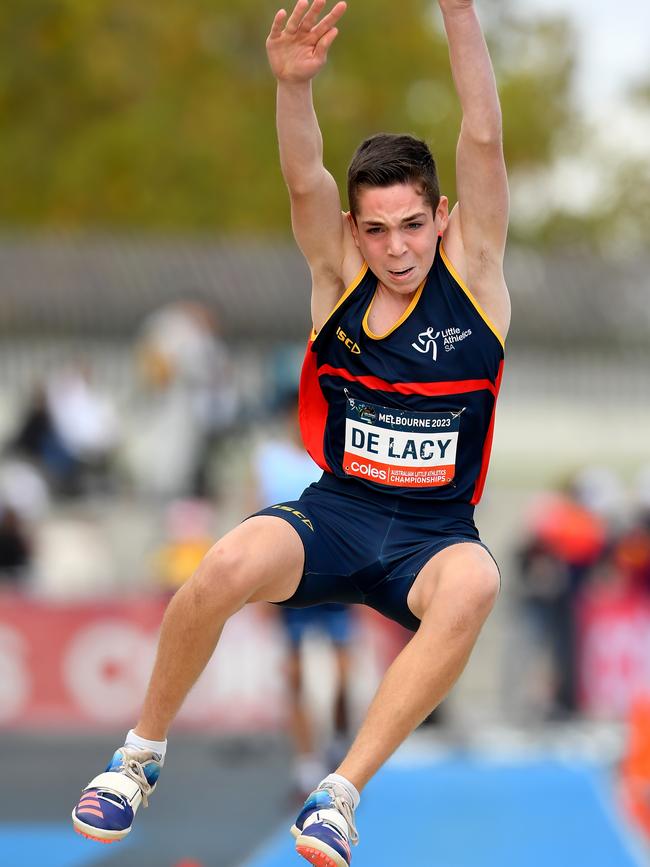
[[72, 746, 163, 843]]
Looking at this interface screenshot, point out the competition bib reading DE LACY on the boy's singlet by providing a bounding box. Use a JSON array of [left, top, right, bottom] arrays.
[[343, 397, 463, 488]]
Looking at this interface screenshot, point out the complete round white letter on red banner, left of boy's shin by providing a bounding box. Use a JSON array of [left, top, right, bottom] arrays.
[[62, 620, 156, 723]]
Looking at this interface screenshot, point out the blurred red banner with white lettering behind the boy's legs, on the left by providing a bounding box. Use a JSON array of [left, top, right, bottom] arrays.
[[0, 594, 389, 731]]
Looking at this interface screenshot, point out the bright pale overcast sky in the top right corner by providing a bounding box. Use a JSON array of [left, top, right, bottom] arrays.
[[520, 0, 650, 109]]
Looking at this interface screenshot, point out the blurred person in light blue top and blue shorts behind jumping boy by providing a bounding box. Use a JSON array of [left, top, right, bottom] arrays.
[[252, 392, 352, 800]]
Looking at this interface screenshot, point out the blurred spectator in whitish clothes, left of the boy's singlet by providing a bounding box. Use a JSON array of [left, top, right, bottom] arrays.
[[126, 301, 239, 497]]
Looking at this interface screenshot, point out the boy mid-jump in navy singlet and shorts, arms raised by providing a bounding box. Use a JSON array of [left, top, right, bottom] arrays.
[[73, 0, 510, 867]]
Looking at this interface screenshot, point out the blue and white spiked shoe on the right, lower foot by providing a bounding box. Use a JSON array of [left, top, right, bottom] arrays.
[[291, 783, 359, 867]]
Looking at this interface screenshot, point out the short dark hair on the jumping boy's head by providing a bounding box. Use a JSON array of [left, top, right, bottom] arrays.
[[348, 132, 440, 217]]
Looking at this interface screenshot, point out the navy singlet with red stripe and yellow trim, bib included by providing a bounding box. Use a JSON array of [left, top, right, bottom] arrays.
[[300, 239, 504, 506]]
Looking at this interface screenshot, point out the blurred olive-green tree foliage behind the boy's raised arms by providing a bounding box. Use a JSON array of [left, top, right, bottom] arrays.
[[0, 0, 572, 234]]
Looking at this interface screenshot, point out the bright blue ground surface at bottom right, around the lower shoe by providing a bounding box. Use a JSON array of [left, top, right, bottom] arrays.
[[246, 758, 646, 867]]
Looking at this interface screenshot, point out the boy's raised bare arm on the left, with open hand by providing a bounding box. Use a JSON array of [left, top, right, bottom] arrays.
[[266, 0, 346, 329]]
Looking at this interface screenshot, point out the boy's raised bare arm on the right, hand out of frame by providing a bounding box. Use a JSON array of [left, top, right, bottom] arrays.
[[439, 0, 510, 336]]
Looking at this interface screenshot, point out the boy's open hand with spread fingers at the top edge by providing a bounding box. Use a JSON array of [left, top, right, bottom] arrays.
[[266, 0, 347, 82]]
